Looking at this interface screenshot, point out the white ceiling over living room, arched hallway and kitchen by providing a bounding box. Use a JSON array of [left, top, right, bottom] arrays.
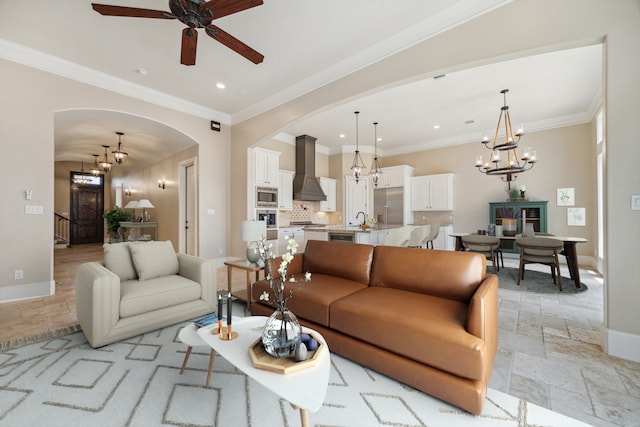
[[0, 0, 602, 171]]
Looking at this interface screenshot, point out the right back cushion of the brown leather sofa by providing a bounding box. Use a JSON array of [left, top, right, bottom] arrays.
[[371, 246, 487, 303]]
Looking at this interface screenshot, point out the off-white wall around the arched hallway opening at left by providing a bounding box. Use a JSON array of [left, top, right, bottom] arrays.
[[0, 60, 230, 301]]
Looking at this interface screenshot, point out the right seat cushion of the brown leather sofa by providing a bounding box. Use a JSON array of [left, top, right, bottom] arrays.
[[329, 288, 489, 380]]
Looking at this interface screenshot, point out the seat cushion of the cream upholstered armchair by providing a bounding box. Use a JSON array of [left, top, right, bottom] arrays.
[[120, 275, 202, 318]]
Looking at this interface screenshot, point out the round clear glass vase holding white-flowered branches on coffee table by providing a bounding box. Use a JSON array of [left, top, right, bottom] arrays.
[[262, 308, 301, 358]]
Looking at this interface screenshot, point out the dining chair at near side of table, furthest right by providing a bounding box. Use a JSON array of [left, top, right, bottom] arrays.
[[516, 237, 564, 291]]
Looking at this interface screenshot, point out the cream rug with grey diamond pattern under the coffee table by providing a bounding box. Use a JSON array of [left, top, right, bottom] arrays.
[[0, 322, 586, 427]]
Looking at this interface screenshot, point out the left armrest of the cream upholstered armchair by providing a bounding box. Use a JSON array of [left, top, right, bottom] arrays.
[[76, 262, 120, 347]]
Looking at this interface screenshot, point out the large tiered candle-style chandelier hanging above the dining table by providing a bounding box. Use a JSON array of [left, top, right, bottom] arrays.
[[475, 89, 538, 189]]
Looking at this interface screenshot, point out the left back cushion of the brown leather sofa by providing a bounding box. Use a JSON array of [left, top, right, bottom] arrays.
[[303, 240, 374, 285]]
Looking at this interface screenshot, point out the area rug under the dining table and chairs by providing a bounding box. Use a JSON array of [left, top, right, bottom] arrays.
[[496, 267, 588, 294]]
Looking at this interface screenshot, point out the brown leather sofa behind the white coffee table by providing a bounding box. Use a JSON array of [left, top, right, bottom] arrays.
[[251, 240, 498, 414]]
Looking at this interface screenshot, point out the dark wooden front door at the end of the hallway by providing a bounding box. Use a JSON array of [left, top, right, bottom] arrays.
[[70, 172, 104, 245]]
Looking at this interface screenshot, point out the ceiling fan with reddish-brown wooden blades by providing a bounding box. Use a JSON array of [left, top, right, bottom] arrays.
[[91, 0, 264, 65]]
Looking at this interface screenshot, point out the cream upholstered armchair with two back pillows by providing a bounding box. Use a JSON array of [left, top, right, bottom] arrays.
[[76, 241, 217, 347]]
